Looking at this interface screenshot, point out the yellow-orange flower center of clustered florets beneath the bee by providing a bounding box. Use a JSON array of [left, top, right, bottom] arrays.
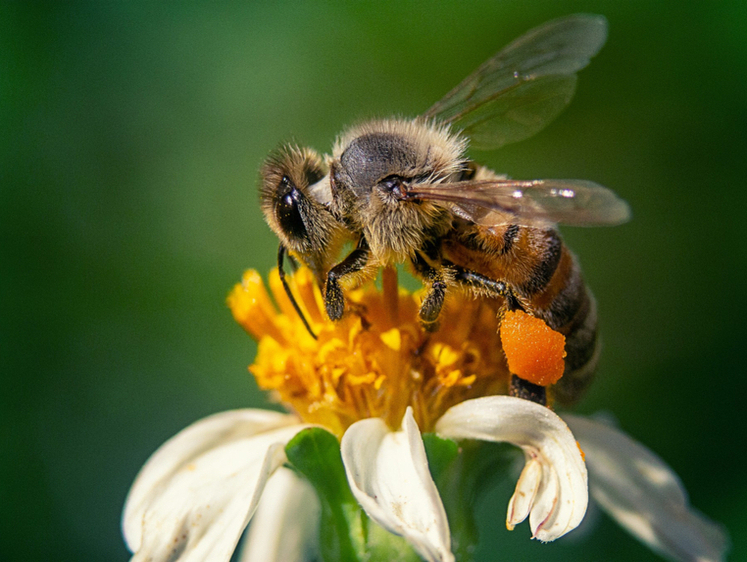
[[228, 268, 509, 435]]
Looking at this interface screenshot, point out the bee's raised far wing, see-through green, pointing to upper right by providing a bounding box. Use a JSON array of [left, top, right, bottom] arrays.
[[423, 14, 607, 149]]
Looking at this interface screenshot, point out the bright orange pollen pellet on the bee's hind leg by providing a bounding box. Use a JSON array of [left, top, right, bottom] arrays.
[[501, 310, 565, 386]]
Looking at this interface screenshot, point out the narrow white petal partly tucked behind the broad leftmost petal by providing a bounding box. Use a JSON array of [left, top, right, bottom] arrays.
[[240, 467, 321, 562]]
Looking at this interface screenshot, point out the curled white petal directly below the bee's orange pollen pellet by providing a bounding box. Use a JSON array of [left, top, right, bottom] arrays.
[[436, 396, 589, 541]]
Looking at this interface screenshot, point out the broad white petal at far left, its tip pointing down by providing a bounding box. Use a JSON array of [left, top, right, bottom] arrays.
[[123, 410, 306, 562]]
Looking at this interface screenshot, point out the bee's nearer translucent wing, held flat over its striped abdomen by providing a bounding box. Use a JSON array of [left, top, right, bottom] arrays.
[[407, 179, 630, 226]]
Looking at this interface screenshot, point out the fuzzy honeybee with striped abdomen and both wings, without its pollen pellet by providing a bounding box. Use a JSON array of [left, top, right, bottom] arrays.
[[261, 14, 630, 403]]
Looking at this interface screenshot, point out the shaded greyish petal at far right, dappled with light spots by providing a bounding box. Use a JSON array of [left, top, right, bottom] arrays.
[[563, 415, 728, 562]]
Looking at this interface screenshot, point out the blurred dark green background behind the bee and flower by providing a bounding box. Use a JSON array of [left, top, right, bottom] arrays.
[[0, 0, 747, 561]]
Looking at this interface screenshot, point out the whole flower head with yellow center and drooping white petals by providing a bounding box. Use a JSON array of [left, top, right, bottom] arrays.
[[123, 269, 725, 562]]
